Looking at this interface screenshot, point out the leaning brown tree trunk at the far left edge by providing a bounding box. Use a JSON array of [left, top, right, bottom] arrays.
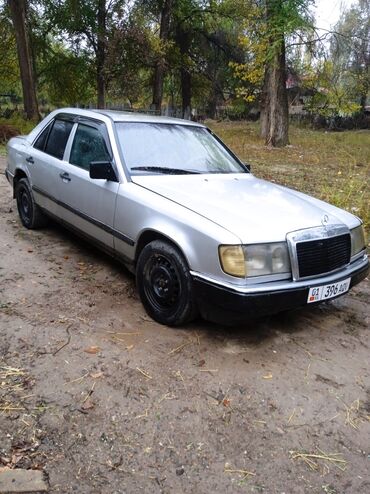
[[9, 0, 40, 120]]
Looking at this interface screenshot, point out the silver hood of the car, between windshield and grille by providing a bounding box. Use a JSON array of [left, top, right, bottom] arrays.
[[132, 174, 359, 243]]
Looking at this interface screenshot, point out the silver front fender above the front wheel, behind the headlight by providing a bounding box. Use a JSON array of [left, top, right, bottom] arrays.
[[114, 182, 241, 283]]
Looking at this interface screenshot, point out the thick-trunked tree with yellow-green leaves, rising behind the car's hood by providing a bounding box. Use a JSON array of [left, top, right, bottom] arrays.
[[234, 0, 312, 146]]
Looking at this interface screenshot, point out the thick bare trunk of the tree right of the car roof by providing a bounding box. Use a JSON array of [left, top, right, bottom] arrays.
[[261, 2, 289, 147]]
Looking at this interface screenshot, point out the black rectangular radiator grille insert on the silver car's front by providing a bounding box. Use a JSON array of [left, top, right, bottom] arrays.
[[296, 234, 351, 278]]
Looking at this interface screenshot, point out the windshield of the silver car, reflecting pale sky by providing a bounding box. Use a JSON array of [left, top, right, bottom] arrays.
[[116, 122, 246, 175]]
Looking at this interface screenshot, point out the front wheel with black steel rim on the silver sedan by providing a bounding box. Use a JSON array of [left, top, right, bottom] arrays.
[[136, 240, 198, 326]]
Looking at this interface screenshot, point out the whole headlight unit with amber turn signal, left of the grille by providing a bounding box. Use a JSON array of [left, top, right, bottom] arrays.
[[219, 242, 291, 278]]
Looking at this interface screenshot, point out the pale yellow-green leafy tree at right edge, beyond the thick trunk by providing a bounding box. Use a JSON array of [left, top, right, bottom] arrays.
[[284, 0, 370, 122]]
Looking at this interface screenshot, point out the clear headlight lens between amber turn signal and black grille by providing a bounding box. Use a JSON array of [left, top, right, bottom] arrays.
[[244, 242, 290, 276]]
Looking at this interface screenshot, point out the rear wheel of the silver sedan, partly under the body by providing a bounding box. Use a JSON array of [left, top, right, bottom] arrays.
[[15, 178, 48, 230]]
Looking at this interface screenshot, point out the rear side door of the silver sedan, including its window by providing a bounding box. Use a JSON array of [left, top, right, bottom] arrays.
[[26, 116, 74, 217]]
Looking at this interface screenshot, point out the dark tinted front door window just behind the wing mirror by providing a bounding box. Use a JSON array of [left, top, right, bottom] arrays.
[[69, 124, 111, 170]]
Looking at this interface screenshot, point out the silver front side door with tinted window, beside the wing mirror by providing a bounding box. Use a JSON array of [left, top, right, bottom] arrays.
[[60, 119, 119, 249]]
